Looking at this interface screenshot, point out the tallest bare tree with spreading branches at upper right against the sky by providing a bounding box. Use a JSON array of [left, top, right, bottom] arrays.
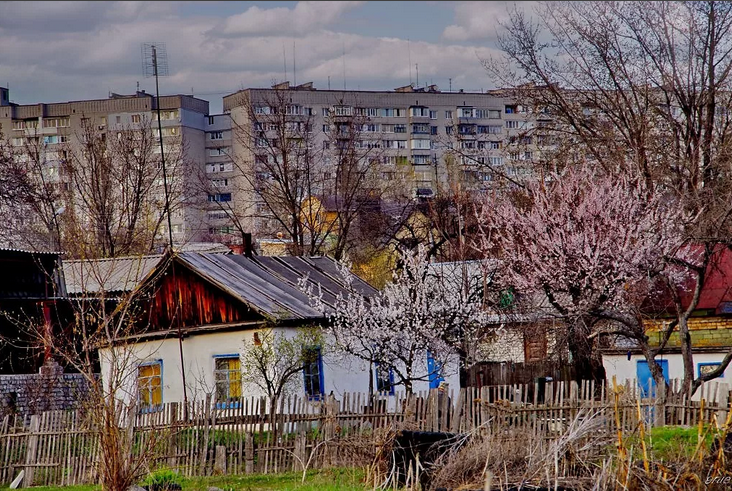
[[485, 1, 732, 398]]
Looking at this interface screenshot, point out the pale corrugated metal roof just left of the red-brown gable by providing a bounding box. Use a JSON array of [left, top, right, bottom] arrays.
[[62, 254, 163, 295]]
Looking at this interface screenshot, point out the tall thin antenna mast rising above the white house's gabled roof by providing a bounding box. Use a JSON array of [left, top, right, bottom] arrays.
[[142, 43, 188, 419]]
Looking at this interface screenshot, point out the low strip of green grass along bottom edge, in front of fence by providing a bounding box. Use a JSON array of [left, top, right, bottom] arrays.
[[16, 469, 366, 491]]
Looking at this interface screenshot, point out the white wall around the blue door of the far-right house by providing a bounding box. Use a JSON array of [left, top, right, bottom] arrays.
[[602, 350, 732, 400]]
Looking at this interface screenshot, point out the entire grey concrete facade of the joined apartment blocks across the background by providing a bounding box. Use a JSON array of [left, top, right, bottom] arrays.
[[0, 82, 542, 252]]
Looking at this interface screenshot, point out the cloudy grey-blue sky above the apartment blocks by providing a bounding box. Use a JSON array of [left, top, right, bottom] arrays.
[[0, 1, 523, 112]]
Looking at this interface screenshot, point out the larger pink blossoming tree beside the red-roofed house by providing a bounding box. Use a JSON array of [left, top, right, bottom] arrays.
[[478, 166, 689, 390]]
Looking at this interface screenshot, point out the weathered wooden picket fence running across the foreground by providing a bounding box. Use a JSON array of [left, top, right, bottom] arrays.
[[0, 381, 730, 486]]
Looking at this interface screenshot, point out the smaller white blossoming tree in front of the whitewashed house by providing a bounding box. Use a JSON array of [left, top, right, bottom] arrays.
[[309, 247, 486, 393]]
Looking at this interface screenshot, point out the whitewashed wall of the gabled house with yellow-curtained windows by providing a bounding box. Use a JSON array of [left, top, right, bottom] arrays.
[[100, 328, 460, 410]]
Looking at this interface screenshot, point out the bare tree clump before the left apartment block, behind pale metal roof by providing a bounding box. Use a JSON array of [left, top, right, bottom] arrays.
[[63, 118, 185, 257]]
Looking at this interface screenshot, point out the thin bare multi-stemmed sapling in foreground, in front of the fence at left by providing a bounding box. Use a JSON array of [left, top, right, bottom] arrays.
[[3, 254, 174, 491]]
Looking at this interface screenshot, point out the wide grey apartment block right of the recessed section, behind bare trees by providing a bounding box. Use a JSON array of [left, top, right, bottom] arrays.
[[222, 82, 544, 248]]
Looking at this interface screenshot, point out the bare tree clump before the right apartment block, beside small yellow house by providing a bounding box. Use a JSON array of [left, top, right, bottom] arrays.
[[232, 89, 398, 258]]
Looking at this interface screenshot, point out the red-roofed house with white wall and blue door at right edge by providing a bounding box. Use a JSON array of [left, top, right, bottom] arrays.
[[602, 246, 732, 398]]
